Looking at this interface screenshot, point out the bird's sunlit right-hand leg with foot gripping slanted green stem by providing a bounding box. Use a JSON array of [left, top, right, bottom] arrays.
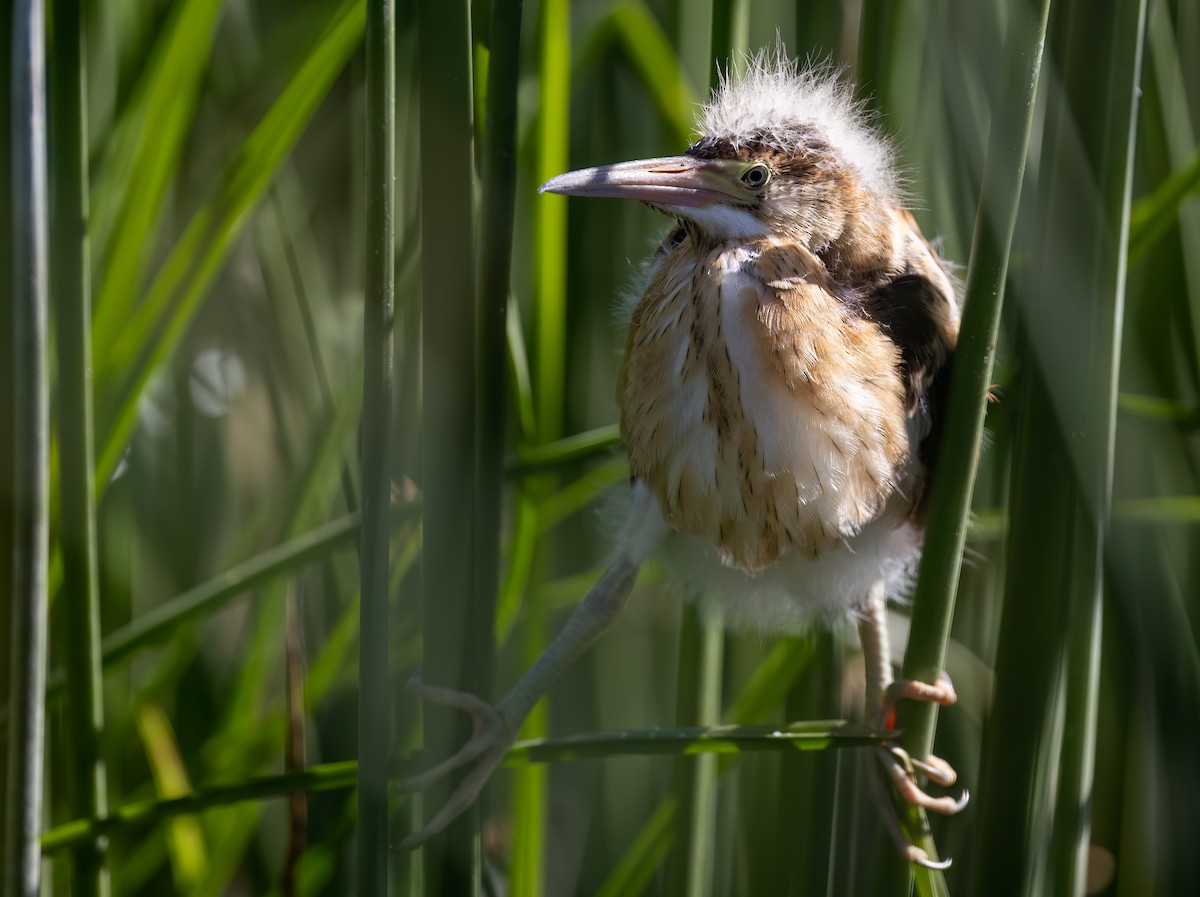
[[858, 582, 968, 868]]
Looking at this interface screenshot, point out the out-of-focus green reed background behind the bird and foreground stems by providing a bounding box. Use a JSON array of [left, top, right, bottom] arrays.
[[2, 0, 1200, 897]]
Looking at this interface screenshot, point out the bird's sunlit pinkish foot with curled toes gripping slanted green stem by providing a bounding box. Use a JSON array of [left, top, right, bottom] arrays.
[[872, 673, 971, 869]]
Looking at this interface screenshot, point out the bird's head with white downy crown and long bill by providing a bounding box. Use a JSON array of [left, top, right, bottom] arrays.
[[539, 50, 896, 249]]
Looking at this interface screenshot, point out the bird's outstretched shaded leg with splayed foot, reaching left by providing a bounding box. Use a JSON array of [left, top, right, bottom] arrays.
[[401, 558, 638, 849]]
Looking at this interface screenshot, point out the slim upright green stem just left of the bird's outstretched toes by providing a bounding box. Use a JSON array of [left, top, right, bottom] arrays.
[[358, 0, 396, 897]]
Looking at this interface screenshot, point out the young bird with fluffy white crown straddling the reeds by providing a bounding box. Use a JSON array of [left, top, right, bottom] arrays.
[[406, 52, 966, 865]]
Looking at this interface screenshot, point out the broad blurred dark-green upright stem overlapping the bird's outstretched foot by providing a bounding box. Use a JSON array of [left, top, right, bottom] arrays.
[[418, 0, 480, 893]]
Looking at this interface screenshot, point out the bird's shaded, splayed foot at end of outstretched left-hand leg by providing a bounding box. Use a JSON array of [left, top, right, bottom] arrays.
[[400, 679, 516, 850]]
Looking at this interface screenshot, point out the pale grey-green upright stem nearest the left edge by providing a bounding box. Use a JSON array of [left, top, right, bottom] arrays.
[[0, 0, 49, 897]]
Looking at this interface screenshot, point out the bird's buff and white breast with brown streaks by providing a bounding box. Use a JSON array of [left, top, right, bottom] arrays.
[[617, 241, 910, 572]]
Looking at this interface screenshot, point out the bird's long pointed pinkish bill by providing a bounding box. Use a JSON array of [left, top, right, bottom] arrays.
[[538, 156, 749, 209]]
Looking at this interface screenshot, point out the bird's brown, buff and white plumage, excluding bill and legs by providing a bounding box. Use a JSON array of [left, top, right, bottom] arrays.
[[604, 58, 958, 628]]
